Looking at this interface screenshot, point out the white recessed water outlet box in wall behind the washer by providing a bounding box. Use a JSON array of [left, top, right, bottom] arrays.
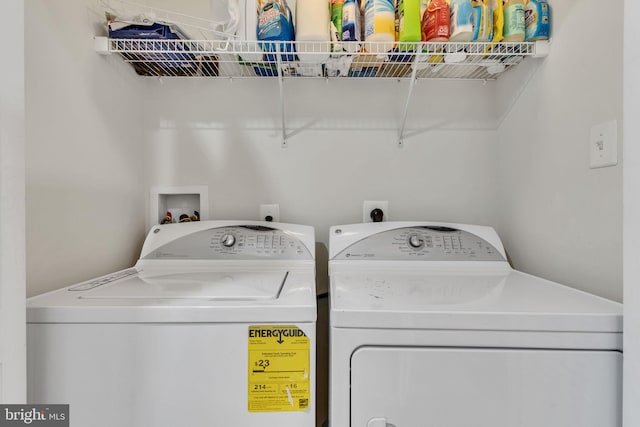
[[147, 185, 209, 228]]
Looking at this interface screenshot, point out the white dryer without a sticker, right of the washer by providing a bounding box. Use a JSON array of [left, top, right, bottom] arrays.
[[329, 222, 622, 427]]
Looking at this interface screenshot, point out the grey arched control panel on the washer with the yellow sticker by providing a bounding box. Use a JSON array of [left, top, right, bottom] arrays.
[[143, 225, 313, 260]]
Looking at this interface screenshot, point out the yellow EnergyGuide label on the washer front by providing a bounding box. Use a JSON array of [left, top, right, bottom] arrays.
[[249, 325, 311, 412]]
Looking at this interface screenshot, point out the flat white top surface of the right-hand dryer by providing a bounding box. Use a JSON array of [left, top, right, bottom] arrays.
[[331, 267, 622, 333]]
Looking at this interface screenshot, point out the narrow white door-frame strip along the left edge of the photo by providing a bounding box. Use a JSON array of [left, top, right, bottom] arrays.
[[0, 0, 27, 403]]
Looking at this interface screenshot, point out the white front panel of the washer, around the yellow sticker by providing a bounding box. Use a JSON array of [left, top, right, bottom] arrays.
[[27, 322, 316, 427]]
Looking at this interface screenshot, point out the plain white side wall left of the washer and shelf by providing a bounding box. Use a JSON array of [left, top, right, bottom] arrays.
[[25, 0, 147, 295]]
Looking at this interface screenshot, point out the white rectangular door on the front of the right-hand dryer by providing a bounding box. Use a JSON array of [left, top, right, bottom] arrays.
[[351, 347, 622, 427]]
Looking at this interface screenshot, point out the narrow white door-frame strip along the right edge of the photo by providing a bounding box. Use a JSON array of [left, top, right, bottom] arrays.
[[623, 0, 640, 427]]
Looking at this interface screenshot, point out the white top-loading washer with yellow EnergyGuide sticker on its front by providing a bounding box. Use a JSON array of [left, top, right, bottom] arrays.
[[27, 221, 316, 427]]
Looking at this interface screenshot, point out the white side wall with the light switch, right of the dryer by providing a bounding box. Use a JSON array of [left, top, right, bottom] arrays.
[[496, 0, 623, 301]]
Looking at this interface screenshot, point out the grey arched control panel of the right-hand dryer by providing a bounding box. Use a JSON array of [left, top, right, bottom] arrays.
[[334, 226, 505, 261]]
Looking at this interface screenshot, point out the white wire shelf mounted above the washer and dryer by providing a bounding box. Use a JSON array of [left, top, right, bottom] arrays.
[[96, 37, 549, 80]]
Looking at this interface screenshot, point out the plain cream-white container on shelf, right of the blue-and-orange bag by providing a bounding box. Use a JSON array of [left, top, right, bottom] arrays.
[[295, 0, 331, 63]]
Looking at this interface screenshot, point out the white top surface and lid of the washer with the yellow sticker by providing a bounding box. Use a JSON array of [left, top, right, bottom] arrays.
[[27, 263, 316, 323]]
